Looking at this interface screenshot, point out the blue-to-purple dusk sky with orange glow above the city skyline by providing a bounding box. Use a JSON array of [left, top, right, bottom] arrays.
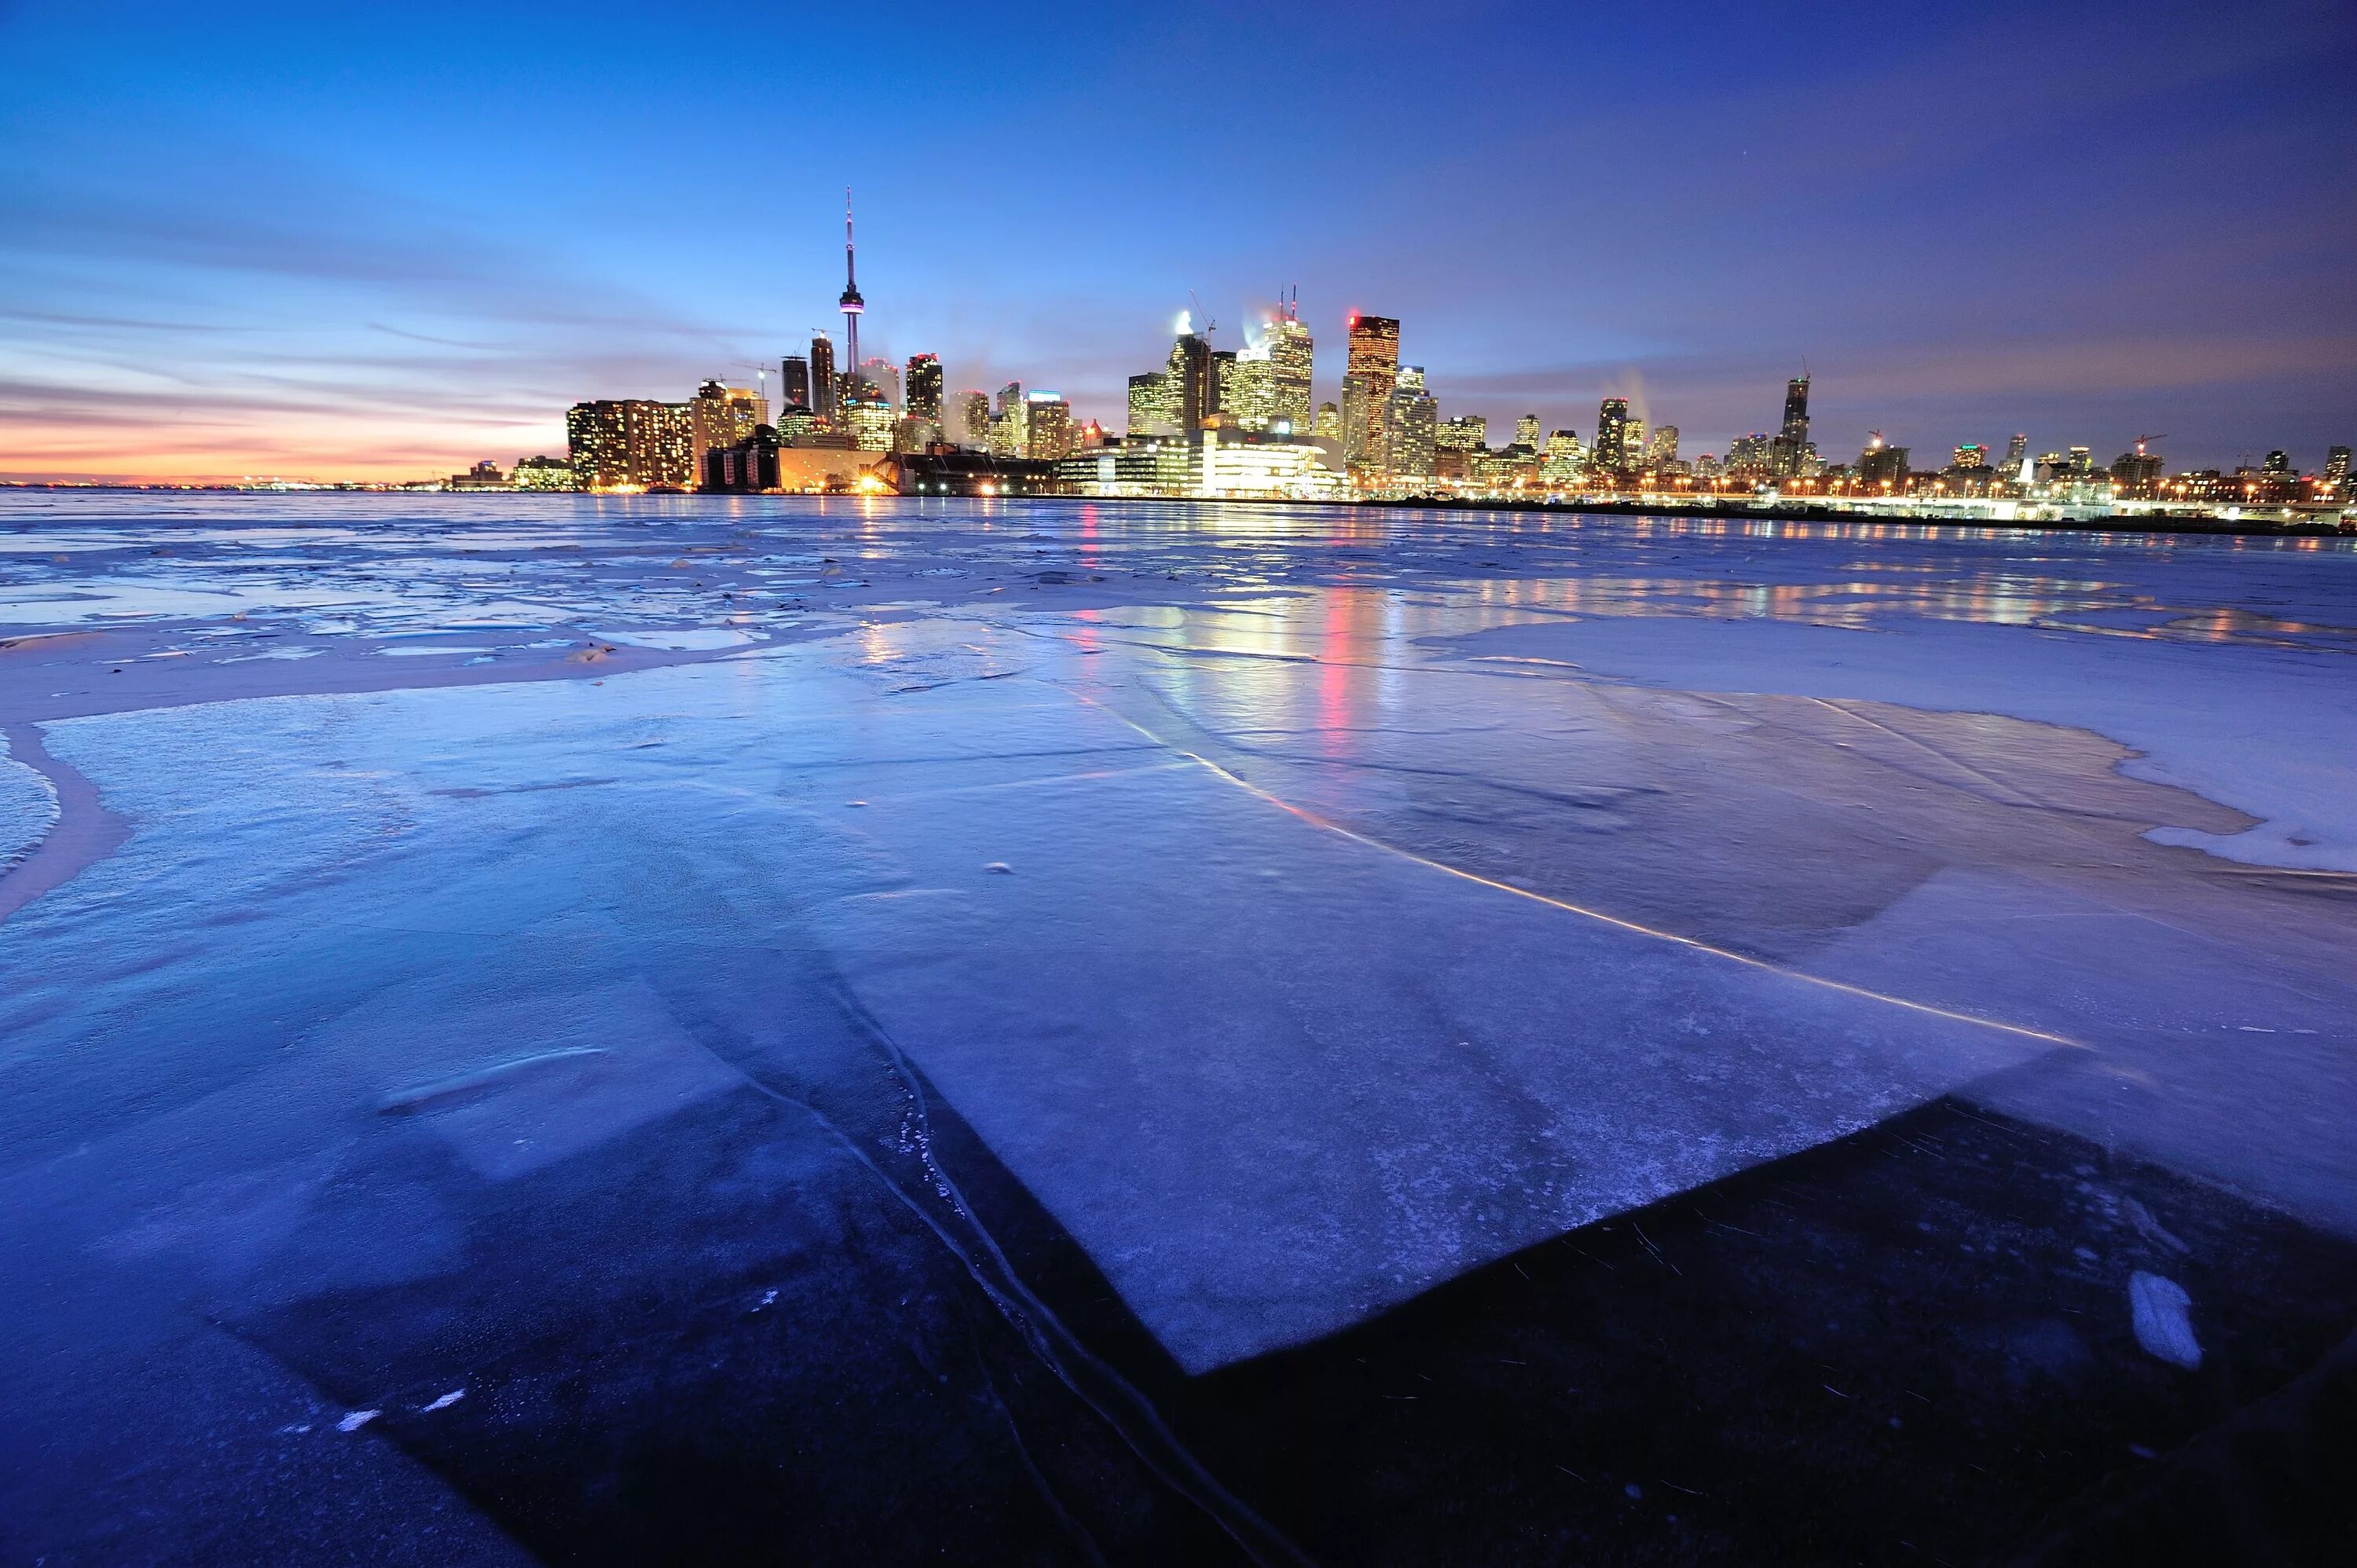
[[0, 0, 2357, 474]]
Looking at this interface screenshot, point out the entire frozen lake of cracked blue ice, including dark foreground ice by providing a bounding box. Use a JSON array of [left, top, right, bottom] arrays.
[[0, 493, 2357, 1563]]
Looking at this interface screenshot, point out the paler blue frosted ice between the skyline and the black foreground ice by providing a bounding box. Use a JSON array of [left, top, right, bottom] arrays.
[[0, 497, 2357, 1537]]
